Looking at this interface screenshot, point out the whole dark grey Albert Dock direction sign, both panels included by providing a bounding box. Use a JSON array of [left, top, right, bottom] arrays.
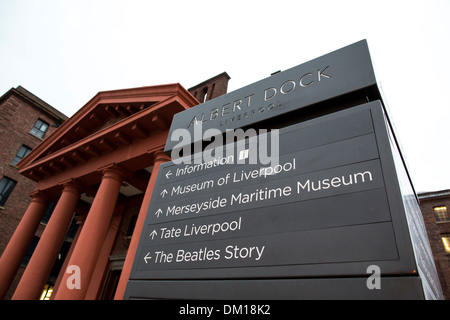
[[125, 41, 442, 299]]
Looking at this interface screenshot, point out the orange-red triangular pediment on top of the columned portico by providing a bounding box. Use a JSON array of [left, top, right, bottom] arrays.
[[19, 84, 198, 181]]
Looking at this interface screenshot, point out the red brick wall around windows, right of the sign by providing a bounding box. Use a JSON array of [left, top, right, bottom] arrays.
[[420, 197, 450, 299]]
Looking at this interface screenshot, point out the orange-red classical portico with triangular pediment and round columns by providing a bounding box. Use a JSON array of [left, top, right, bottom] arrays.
[[0, 84, 198, 299]]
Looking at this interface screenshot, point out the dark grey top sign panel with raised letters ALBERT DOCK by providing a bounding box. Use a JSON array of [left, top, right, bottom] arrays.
[[165, 40, 378, 153]]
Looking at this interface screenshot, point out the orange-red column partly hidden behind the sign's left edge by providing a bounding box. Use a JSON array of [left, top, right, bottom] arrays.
[[114, 151, 170, 300]]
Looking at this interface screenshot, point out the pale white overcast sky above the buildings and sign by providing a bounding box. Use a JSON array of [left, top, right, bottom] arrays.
[[0, 0, 450, 192]]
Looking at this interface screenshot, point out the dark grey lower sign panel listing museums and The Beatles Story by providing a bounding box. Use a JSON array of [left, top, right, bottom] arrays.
[[125, 101, 439, 299]]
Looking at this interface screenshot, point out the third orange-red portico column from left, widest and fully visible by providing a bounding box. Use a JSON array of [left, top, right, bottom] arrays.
[[55, 166, 125, 300]]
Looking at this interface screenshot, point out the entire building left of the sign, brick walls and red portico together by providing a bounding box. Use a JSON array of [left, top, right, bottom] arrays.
[[0, 73, 230, 299]]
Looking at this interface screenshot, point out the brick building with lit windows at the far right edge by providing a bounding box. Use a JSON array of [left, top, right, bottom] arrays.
[[418, 190, 450, 300]]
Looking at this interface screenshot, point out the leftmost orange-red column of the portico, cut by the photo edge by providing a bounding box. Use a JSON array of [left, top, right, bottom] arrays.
[[0, 191, 48, 300]]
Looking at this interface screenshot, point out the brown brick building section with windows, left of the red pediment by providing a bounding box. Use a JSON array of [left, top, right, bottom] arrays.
[[0, 86, 67, 296]]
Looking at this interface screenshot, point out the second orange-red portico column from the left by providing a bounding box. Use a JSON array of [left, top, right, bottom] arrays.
[[13, 181, 80, 300]]
